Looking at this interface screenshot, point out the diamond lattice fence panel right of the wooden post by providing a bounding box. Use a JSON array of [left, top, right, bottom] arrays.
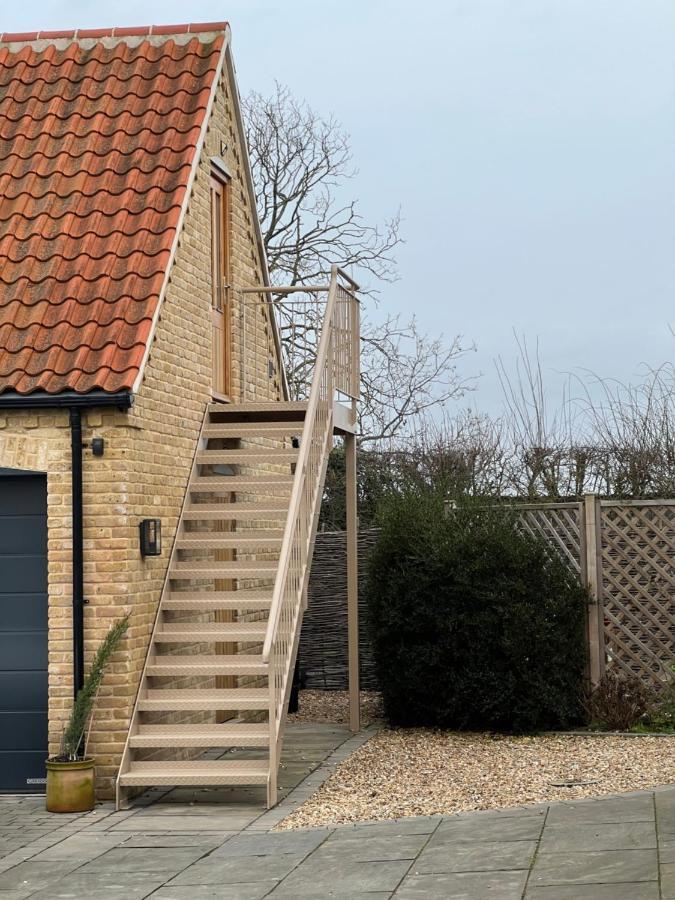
[[601, 501, 675, 683]]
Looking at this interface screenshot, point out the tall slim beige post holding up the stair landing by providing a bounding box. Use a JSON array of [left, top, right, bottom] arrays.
[[345, 434, 361, 731]]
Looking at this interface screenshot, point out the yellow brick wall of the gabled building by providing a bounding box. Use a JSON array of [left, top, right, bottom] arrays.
[[0, 47, 280, 797]]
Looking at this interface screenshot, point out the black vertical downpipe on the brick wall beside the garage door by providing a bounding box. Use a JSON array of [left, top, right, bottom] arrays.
[[70, 407, 84, 696]]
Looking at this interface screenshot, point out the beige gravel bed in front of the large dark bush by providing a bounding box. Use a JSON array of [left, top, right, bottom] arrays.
[[278, 729, 675, 829]]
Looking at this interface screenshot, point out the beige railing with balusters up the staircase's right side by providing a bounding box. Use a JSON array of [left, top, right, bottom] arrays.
[[262, 266, 360, 756]]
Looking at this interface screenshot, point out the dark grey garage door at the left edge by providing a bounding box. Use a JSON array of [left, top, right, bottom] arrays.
[[0, 469, 47, 793]]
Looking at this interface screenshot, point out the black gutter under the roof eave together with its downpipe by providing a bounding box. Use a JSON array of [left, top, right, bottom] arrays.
[[0, 391, 134, 697]]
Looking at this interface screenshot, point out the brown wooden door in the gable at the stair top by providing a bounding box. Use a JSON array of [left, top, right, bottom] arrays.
[[210, 175, 232, 397]]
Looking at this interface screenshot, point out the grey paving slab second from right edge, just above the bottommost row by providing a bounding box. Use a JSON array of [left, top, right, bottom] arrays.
[[530, 850, 658, 887]]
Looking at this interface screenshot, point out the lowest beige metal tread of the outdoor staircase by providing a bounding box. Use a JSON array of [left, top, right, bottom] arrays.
[[120, 759, 269, 786]]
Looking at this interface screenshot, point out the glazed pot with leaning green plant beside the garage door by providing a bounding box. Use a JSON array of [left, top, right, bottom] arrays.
[[47, 613, 129, 812]]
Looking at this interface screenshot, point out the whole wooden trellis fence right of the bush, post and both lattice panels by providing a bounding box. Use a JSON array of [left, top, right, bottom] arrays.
[[519, 495, 675, 684]]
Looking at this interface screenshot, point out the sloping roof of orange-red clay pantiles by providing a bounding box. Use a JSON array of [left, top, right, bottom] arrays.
[[0, 22, 227, 393]]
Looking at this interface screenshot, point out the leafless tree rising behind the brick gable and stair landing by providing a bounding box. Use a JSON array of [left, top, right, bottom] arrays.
[[243, 84, 471, 443]]
